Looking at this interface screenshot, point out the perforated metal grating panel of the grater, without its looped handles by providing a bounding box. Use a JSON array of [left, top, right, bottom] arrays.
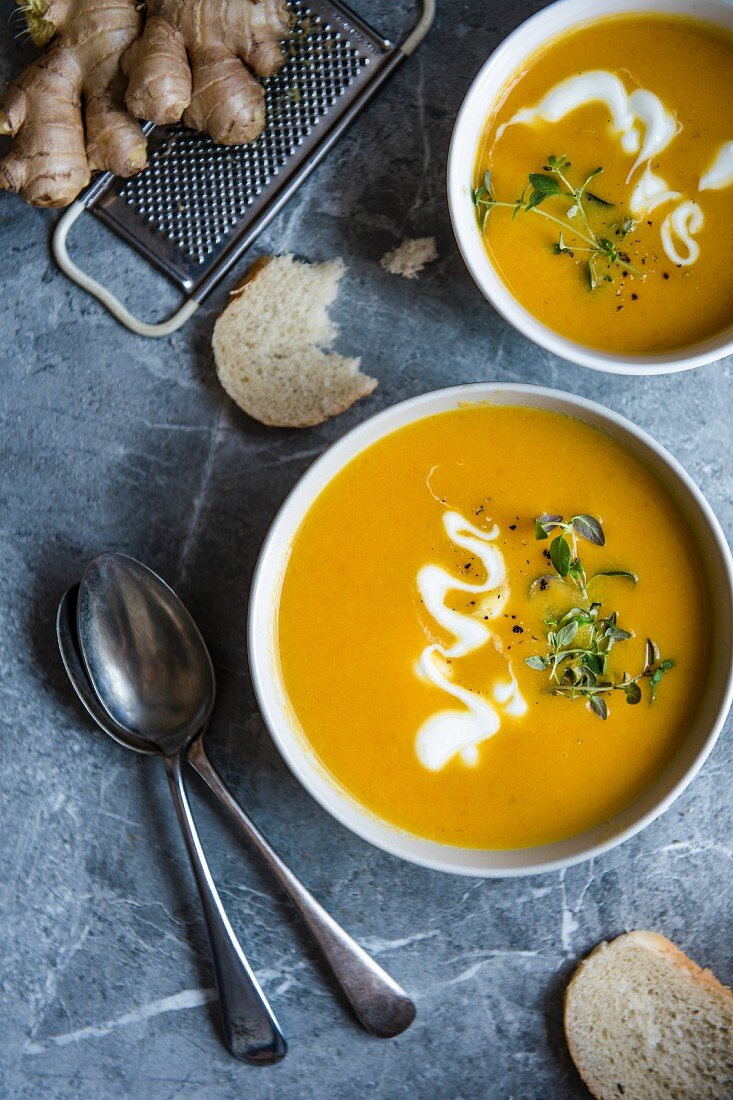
[[92, 0, 396, 292]]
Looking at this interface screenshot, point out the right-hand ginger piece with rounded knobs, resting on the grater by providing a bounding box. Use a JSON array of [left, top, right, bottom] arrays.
[[124, 0, 291, 145]]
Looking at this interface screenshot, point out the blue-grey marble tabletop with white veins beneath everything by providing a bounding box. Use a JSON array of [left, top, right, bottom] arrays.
[[0, 0, 733, 1100]]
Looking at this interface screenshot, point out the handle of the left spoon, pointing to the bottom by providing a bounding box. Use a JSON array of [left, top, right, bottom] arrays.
[[164, 754, 287, 1065]]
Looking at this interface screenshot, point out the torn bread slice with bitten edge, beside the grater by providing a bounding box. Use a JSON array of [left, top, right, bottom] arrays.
[[211, 254, 376, 428]]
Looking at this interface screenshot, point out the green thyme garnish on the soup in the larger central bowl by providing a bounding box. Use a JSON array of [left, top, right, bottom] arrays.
[[525, 513, 674, 718]]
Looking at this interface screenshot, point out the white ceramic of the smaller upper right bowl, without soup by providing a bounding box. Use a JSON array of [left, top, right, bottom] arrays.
[[448, 0, 733, 374]]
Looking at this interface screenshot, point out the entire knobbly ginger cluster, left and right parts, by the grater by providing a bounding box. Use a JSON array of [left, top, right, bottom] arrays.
[[0, 0, 291, 207]]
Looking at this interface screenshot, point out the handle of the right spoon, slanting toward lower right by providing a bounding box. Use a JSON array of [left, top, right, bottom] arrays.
[[188, 736, 415, 1038]]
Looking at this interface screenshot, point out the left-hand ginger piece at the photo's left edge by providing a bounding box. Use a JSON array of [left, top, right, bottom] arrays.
[[0, 0, 146, 207]]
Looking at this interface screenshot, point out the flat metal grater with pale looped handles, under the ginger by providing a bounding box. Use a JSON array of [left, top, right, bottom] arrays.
[[53, 0, 435, 337]]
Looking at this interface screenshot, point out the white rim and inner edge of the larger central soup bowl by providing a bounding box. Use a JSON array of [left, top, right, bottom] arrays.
[[248, 382, 733, 878]]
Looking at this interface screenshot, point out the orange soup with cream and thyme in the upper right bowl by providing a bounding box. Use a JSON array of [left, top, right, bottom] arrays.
[[474, 14, 733, 354]]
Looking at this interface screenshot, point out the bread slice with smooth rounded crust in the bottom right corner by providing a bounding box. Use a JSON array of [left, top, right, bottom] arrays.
[[565, 932, 733, 1100]]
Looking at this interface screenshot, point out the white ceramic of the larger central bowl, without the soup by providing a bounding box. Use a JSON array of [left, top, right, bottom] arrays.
[[249, 383, 733, 877]]
